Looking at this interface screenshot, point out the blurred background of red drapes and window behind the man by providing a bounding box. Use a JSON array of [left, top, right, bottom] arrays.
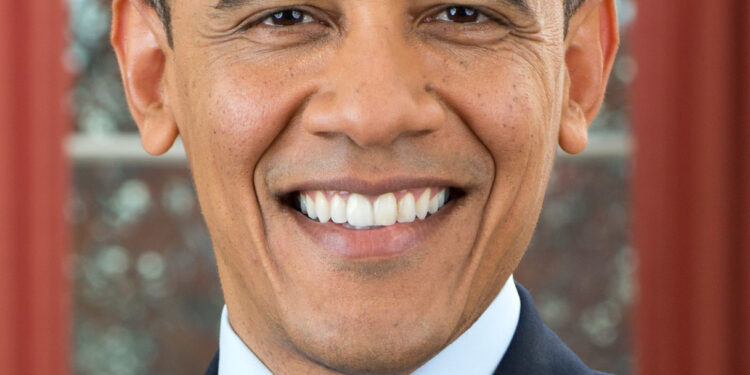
[[0, 0, 750, 375]]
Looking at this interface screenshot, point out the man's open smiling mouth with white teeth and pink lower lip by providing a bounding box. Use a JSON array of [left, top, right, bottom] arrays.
[[284, 183, 465, 260]]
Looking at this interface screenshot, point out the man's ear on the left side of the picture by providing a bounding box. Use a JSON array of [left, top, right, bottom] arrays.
[[111, 0, 179, 155]]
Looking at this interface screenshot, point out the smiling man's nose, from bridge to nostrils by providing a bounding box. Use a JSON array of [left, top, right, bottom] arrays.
[[302, 25, 445, 148]]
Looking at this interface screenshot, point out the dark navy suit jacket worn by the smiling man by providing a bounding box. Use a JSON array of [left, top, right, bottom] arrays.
[[206, 283, 604, 375]]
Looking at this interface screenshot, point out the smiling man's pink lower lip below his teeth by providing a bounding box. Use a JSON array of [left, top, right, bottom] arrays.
[[293, 201, 454, 259]]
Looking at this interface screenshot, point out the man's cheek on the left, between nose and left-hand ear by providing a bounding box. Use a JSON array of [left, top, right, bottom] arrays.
[[169, 58, 322, 248]]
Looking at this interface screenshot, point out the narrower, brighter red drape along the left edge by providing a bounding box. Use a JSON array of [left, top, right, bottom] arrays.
[[0, 0, 71, 375]]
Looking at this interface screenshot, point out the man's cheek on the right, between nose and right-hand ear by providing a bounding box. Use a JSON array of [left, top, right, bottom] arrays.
[[428, 57, 556, 232]]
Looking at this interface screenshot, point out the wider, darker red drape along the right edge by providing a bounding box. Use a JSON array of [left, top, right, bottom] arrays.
[[632, 0, 750, 375]]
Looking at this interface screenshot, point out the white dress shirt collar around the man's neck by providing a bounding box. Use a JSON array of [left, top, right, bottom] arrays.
[[219, 276, 521, 375]]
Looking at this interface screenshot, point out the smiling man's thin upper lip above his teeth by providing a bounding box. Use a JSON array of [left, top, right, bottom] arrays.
[[278, 176, 462, 196]]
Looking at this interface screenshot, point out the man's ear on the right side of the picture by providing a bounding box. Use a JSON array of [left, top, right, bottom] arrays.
[[559, 0, 620, 154]]
